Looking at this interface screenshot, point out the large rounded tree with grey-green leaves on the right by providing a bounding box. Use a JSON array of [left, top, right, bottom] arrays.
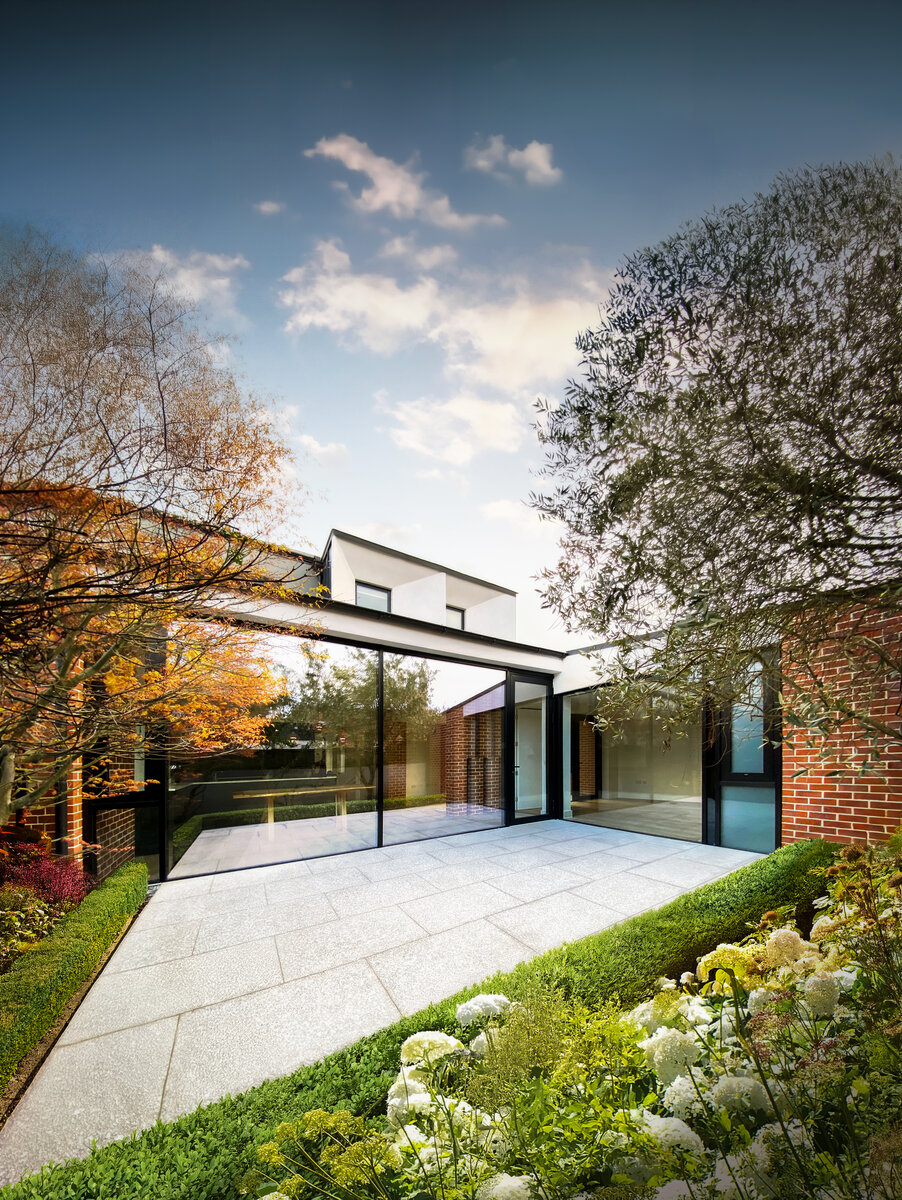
[[535, 160, 902, 766]]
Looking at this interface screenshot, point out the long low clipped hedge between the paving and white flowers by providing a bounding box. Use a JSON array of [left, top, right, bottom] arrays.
[[0, 841, 836, 1200]]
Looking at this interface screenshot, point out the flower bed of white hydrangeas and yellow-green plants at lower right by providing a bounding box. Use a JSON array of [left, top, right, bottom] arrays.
[[247, 839, 902, 1200]]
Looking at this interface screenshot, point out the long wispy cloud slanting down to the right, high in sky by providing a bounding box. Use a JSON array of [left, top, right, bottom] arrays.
[[303, 133, 506, 233]]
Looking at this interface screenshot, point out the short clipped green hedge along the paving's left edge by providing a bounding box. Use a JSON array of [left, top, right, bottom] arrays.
[[0, 863, 148, 1087]]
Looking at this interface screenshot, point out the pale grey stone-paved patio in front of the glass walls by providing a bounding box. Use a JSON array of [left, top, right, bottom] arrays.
[[0, 821, 759, 1183]]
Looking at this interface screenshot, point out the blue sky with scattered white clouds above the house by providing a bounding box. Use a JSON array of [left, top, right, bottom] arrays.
[[0, 0, 902, 647]]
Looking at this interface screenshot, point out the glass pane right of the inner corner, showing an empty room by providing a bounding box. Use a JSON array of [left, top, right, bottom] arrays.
[[564, 691, 702, 841]]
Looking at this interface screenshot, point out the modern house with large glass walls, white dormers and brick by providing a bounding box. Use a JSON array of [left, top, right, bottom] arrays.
[[21, 530, 902, 880]]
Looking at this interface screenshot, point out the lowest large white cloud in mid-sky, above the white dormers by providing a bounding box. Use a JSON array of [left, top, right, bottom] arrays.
[[387, 392, 525, 467]]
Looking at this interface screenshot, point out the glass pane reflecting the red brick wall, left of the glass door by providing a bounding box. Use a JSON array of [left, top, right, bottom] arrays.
[[383, 654, 504, 845]]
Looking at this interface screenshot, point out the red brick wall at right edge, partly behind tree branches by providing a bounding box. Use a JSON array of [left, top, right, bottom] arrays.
[[782, 605, 902, 842]]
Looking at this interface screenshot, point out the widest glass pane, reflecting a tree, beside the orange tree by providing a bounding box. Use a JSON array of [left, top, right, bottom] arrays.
[[168, 638, 378, 878]]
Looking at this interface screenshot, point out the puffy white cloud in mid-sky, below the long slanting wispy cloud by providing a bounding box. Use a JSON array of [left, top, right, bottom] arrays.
[[279, 241, 439, 354]]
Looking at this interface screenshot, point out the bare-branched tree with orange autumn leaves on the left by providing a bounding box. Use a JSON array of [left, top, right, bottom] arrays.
[[0, 230, 316, 821]]
